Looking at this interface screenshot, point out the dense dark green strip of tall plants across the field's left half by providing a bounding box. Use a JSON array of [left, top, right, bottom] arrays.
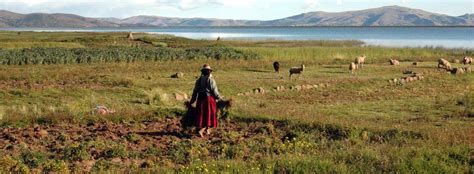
[[0, 47, 259, 65]]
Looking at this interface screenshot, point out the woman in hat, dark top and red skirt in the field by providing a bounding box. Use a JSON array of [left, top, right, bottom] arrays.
[[190, 64, 221, 137]]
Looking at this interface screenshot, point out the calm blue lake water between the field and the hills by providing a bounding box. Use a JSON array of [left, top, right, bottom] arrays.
[[0, 27, 474, 49]]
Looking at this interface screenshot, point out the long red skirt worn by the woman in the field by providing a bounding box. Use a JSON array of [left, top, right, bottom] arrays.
[[196, 96, 217, 128]]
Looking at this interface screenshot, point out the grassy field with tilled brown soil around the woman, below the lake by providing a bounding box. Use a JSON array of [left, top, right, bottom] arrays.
[[0, 32, 474, 173]]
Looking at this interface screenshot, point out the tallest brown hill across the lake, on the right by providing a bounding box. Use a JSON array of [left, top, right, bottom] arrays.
[[262, 6, 474, 26]]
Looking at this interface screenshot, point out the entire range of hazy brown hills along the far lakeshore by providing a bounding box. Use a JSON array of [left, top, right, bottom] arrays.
[[0, 6, 474, 28]]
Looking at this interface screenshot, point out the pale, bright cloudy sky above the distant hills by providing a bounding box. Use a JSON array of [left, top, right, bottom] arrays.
[[0, 0, 474, 20]]
